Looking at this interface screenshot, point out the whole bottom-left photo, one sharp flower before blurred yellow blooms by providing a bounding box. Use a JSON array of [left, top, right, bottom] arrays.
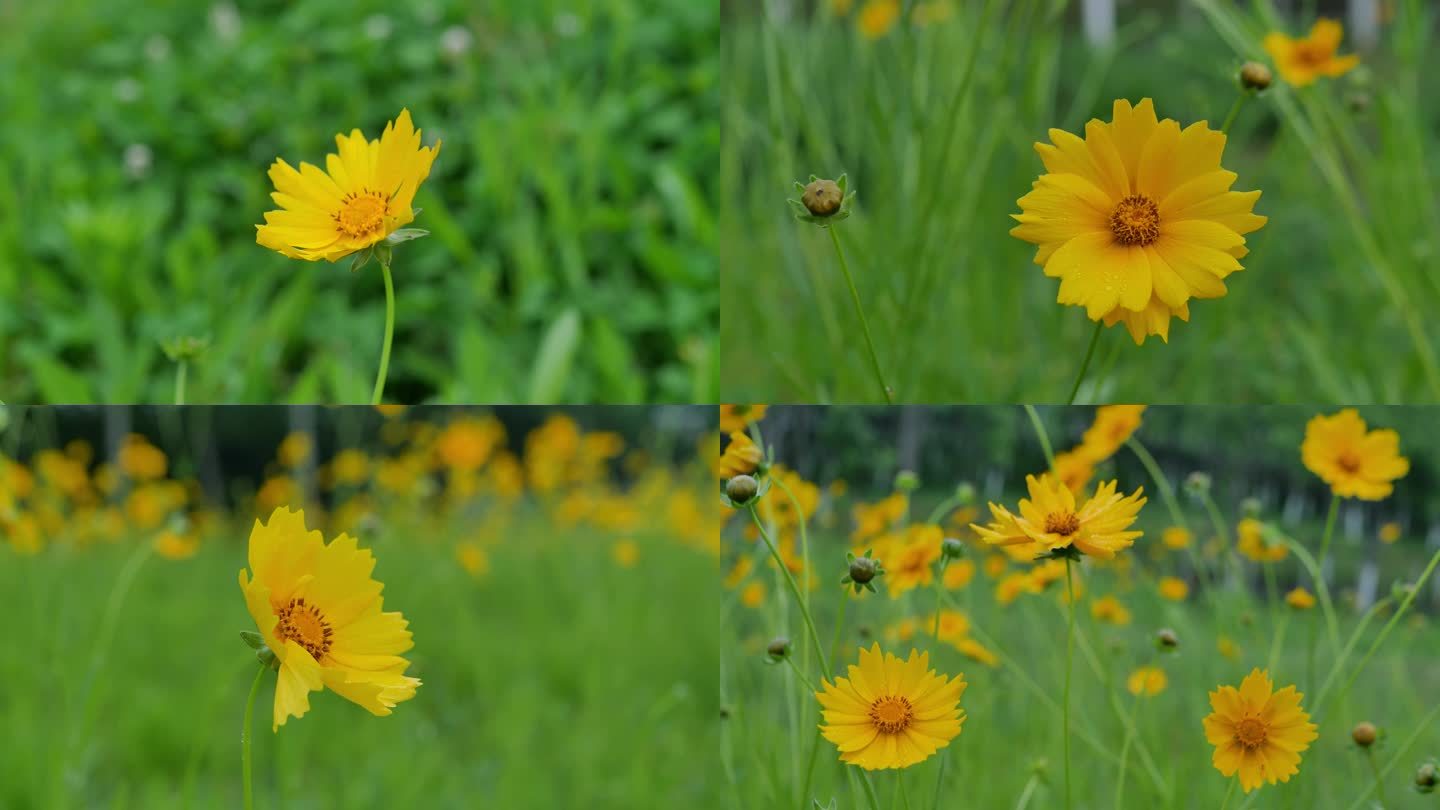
[[0, 406, 721, 810]]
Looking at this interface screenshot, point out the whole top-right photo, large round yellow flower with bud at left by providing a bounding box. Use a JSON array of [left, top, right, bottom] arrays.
[[720, 0, 1440, 405]]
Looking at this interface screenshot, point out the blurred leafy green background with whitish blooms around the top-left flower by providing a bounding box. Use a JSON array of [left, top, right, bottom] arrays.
[[0, 0, 720, 402]]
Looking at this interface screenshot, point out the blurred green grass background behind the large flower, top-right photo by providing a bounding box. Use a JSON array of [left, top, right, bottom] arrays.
[[720, 0, 1440, 404]]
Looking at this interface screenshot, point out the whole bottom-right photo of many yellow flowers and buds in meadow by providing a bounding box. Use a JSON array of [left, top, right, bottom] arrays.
[[719, 405, 1440, 810]]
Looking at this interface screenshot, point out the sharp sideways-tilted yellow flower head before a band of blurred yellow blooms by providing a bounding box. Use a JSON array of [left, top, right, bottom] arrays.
[[239, 507, 420, 731]]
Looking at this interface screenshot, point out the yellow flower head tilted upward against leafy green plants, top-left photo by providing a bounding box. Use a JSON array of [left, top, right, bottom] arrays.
[[255, 110, 441, 261]]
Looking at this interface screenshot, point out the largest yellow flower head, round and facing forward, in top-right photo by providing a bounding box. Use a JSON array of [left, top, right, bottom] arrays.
[[1011, 98, 1266, 343]]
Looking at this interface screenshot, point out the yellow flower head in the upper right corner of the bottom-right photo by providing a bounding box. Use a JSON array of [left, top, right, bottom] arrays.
[[1300, 408, 1410, 500]]
